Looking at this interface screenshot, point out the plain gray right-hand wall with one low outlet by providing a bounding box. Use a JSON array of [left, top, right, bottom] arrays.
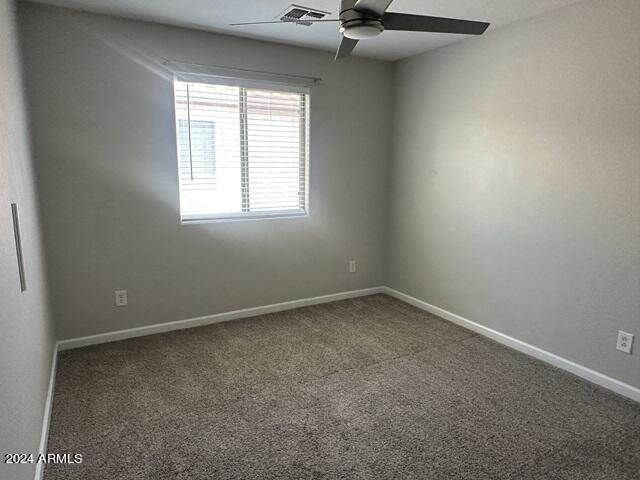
[[388, 0, 640, 387]]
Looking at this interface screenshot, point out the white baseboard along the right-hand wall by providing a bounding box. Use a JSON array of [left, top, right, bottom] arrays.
[[382, 287, 640, 402]]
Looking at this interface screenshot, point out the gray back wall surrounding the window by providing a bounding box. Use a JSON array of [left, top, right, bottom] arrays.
[[21, 4, 392, 339]]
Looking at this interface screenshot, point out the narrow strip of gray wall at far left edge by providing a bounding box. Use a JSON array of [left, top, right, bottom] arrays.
[[0, 0, 53, 480]]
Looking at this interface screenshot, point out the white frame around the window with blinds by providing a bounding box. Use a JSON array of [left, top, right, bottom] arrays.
[[173, 73, 311, 225]]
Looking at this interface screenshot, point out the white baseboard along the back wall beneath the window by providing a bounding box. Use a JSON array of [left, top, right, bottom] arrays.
[[58, 287, 384, 350]]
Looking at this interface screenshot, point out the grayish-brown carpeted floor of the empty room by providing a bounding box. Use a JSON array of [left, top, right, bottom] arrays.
[[45, 295, 640, 480]]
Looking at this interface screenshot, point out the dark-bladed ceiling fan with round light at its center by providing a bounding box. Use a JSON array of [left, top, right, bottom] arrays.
[[231, 0, 489, 60]]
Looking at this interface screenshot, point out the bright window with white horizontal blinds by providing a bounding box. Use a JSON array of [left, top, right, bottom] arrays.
[[174, 80, 309, 223]]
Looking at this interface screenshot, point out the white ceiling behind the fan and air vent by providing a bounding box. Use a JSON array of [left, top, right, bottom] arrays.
[[25, 0, 580, 60]]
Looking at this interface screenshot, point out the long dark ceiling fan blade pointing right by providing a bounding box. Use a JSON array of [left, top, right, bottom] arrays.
[[382, 13, 490, 35]]
